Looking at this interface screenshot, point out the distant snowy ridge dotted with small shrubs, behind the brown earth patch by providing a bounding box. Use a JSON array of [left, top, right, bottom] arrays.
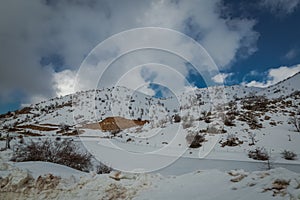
[[0, 82, 260, 133]]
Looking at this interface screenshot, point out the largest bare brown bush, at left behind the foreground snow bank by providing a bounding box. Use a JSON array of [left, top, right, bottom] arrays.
[[11, 139, 92, 171]]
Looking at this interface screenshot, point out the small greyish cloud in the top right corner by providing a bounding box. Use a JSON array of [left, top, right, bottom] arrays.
[[261, 0, 300, 14]]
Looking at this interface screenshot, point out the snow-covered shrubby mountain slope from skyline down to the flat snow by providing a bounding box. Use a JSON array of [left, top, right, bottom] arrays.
[[0, 73, 300, 167]]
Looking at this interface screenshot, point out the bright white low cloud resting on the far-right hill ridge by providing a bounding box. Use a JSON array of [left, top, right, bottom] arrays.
[[242, 64, 300, 88]]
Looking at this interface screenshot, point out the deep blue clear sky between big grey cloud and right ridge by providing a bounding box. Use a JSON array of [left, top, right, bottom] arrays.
[[228, 1, 300, 82]]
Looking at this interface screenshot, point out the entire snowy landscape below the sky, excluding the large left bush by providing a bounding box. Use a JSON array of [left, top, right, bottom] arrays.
[[0, 73, 300, 199]]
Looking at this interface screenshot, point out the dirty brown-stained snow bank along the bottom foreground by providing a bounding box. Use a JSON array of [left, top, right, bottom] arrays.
[[0, 162, 300, 200]]
